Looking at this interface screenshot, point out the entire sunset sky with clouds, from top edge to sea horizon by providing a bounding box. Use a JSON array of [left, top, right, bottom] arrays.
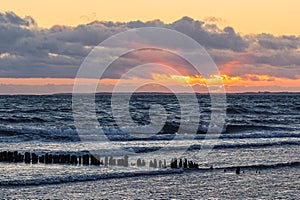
[[0, 0, 300, 94]]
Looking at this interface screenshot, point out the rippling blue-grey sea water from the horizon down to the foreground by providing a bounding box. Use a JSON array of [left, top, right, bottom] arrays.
[[0, 93, 300, 199]]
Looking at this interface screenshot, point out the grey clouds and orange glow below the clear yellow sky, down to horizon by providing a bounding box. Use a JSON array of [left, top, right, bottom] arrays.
[[0, 11, 300, 94]]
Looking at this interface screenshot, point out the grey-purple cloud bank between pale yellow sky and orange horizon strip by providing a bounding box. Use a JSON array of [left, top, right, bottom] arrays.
[[0, 12, 300, 78]]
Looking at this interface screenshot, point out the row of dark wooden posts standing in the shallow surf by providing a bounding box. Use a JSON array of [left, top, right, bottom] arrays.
[[0, 151, 202, 169]]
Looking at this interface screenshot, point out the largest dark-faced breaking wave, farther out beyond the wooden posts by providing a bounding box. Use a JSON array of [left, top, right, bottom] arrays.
[[0, 125, 300, 142]]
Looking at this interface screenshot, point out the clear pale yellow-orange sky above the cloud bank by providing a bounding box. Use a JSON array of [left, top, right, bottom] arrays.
[[0, 0, 300, 35]]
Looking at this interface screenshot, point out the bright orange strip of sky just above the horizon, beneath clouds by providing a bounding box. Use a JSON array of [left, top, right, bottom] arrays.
[[0, 74, 300, 93]]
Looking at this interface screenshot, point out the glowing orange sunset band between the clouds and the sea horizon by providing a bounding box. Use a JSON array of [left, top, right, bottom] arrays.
[[0, 73, 300, 93]]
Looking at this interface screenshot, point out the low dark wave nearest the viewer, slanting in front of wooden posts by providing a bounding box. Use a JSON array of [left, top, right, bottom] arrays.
[[0, 161, 300, 187]]
